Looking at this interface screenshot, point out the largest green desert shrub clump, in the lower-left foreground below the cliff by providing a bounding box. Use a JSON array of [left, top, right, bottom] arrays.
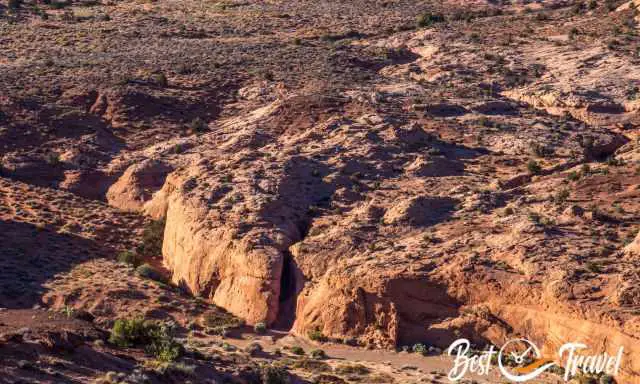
[[109, 317, 184, 362]]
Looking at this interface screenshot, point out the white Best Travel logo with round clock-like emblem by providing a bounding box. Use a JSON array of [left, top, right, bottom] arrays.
[[447, 339, 624, 383]]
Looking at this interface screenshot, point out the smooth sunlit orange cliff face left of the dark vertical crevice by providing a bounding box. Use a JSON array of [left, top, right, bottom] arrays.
[[162, 196, 283, 324]]
